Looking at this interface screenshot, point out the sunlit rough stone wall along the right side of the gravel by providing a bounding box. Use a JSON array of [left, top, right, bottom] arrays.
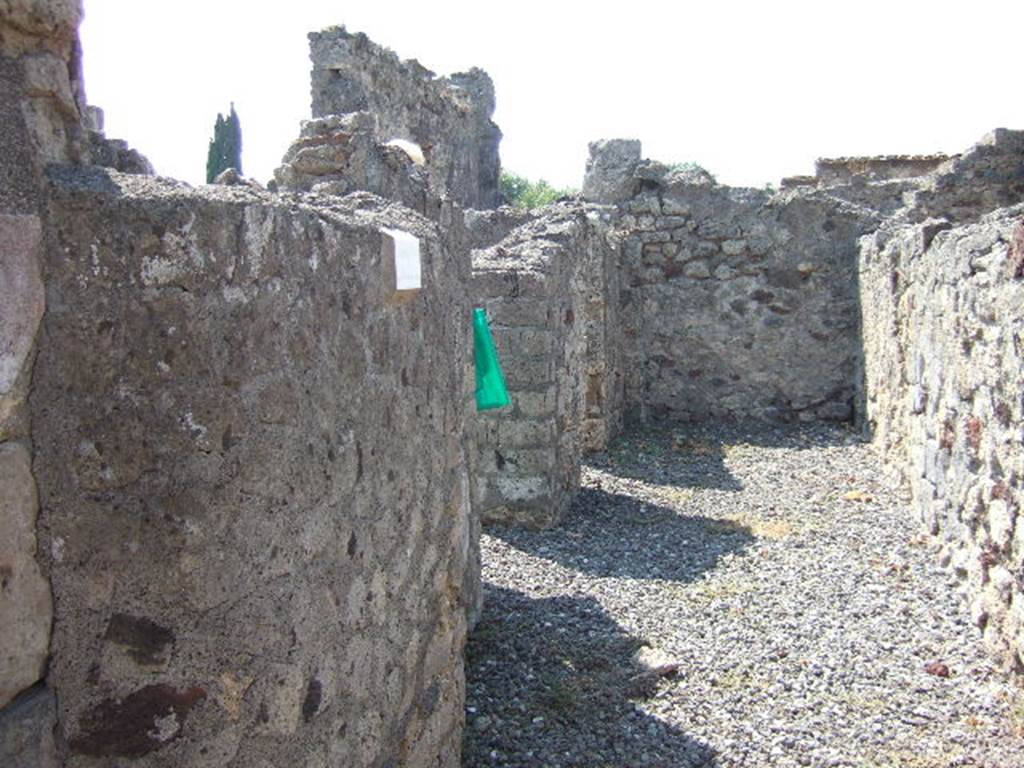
[[860, 206, 1024, 672]]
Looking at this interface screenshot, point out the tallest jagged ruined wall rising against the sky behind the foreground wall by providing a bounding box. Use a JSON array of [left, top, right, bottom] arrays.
[[309, 27, 502, 209]]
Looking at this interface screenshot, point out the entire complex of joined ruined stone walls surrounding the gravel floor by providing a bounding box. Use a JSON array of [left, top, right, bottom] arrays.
[[0, 15, 1024, 767]]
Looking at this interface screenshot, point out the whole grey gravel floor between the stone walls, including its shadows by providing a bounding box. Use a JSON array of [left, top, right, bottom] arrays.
[[463, 426, 1024, 768]]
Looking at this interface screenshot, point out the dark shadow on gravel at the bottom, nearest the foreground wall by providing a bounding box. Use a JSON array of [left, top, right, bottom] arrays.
[[463, 584, 718, 768]]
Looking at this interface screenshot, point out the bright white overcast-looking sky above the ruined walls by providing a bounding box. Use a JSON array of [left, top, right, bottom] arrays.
[[82, 0, 1024, 186]]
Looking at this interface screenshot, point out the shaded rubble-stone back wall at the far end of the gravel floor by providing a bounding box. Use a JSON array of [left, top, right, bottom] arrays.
[[598, 154, 879, 421]]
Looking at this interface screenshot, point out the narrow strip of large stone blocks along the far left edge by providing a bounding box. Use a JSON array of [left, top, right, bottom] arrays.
[[0, 0, 85, 768]]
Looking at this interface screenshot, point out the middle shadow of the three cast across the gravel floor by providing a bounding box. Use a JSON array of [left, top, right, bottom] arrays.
[[486, 487, 755, 582]]
